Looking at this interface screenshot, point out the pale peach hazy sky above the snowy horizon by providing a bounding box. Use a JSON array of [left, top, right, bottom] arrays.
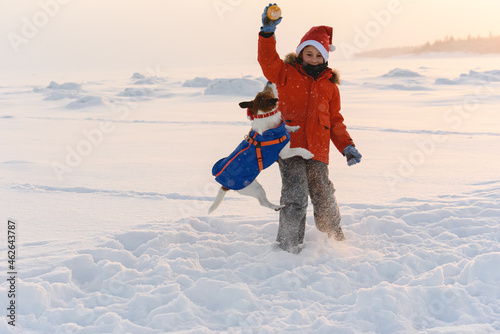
[[0, 0, 500, 70]]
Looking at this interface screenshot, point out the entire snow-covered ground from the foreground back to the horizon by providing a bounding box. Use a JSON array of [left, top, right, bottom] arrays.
[[0, 55, 500, 334]]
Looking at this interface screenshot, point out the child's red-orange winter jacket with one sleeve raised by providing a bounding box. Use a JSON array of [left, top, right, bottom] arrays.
[[258, 35, 354, 164]]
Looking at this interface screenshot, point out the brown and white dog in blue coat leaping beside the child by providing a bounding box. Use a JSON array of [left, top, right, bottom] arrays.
[[208, 82, 313, 213]]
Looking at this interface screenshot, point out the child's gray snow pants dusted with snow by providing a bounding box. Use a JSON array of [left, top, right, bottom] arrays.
[[276, 156, 341, 250]]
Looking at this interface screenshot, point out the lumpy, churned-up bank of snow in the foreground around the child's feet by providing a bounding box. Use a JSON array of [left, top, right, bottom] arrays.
[[0, 187, 500, 333]]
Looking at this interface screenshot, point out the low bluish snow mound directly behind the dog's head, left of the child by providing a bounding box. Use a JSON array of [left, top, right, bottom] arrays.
[[205, 78, 264, 96]]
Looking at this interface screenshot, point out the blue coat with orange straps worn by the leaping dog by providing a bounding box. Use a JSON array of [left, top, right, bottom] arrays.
[[212, 122, 290, 190]]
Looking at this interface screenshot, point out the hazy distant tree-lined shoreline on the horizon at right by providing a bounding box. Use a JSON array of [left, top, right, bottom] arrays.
[[355, 35, 500, 58]]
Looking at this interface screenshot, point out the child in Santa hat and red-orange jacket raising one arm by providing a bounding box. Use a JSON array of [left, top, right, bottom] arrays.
[[258, 4, 361, 254]]
